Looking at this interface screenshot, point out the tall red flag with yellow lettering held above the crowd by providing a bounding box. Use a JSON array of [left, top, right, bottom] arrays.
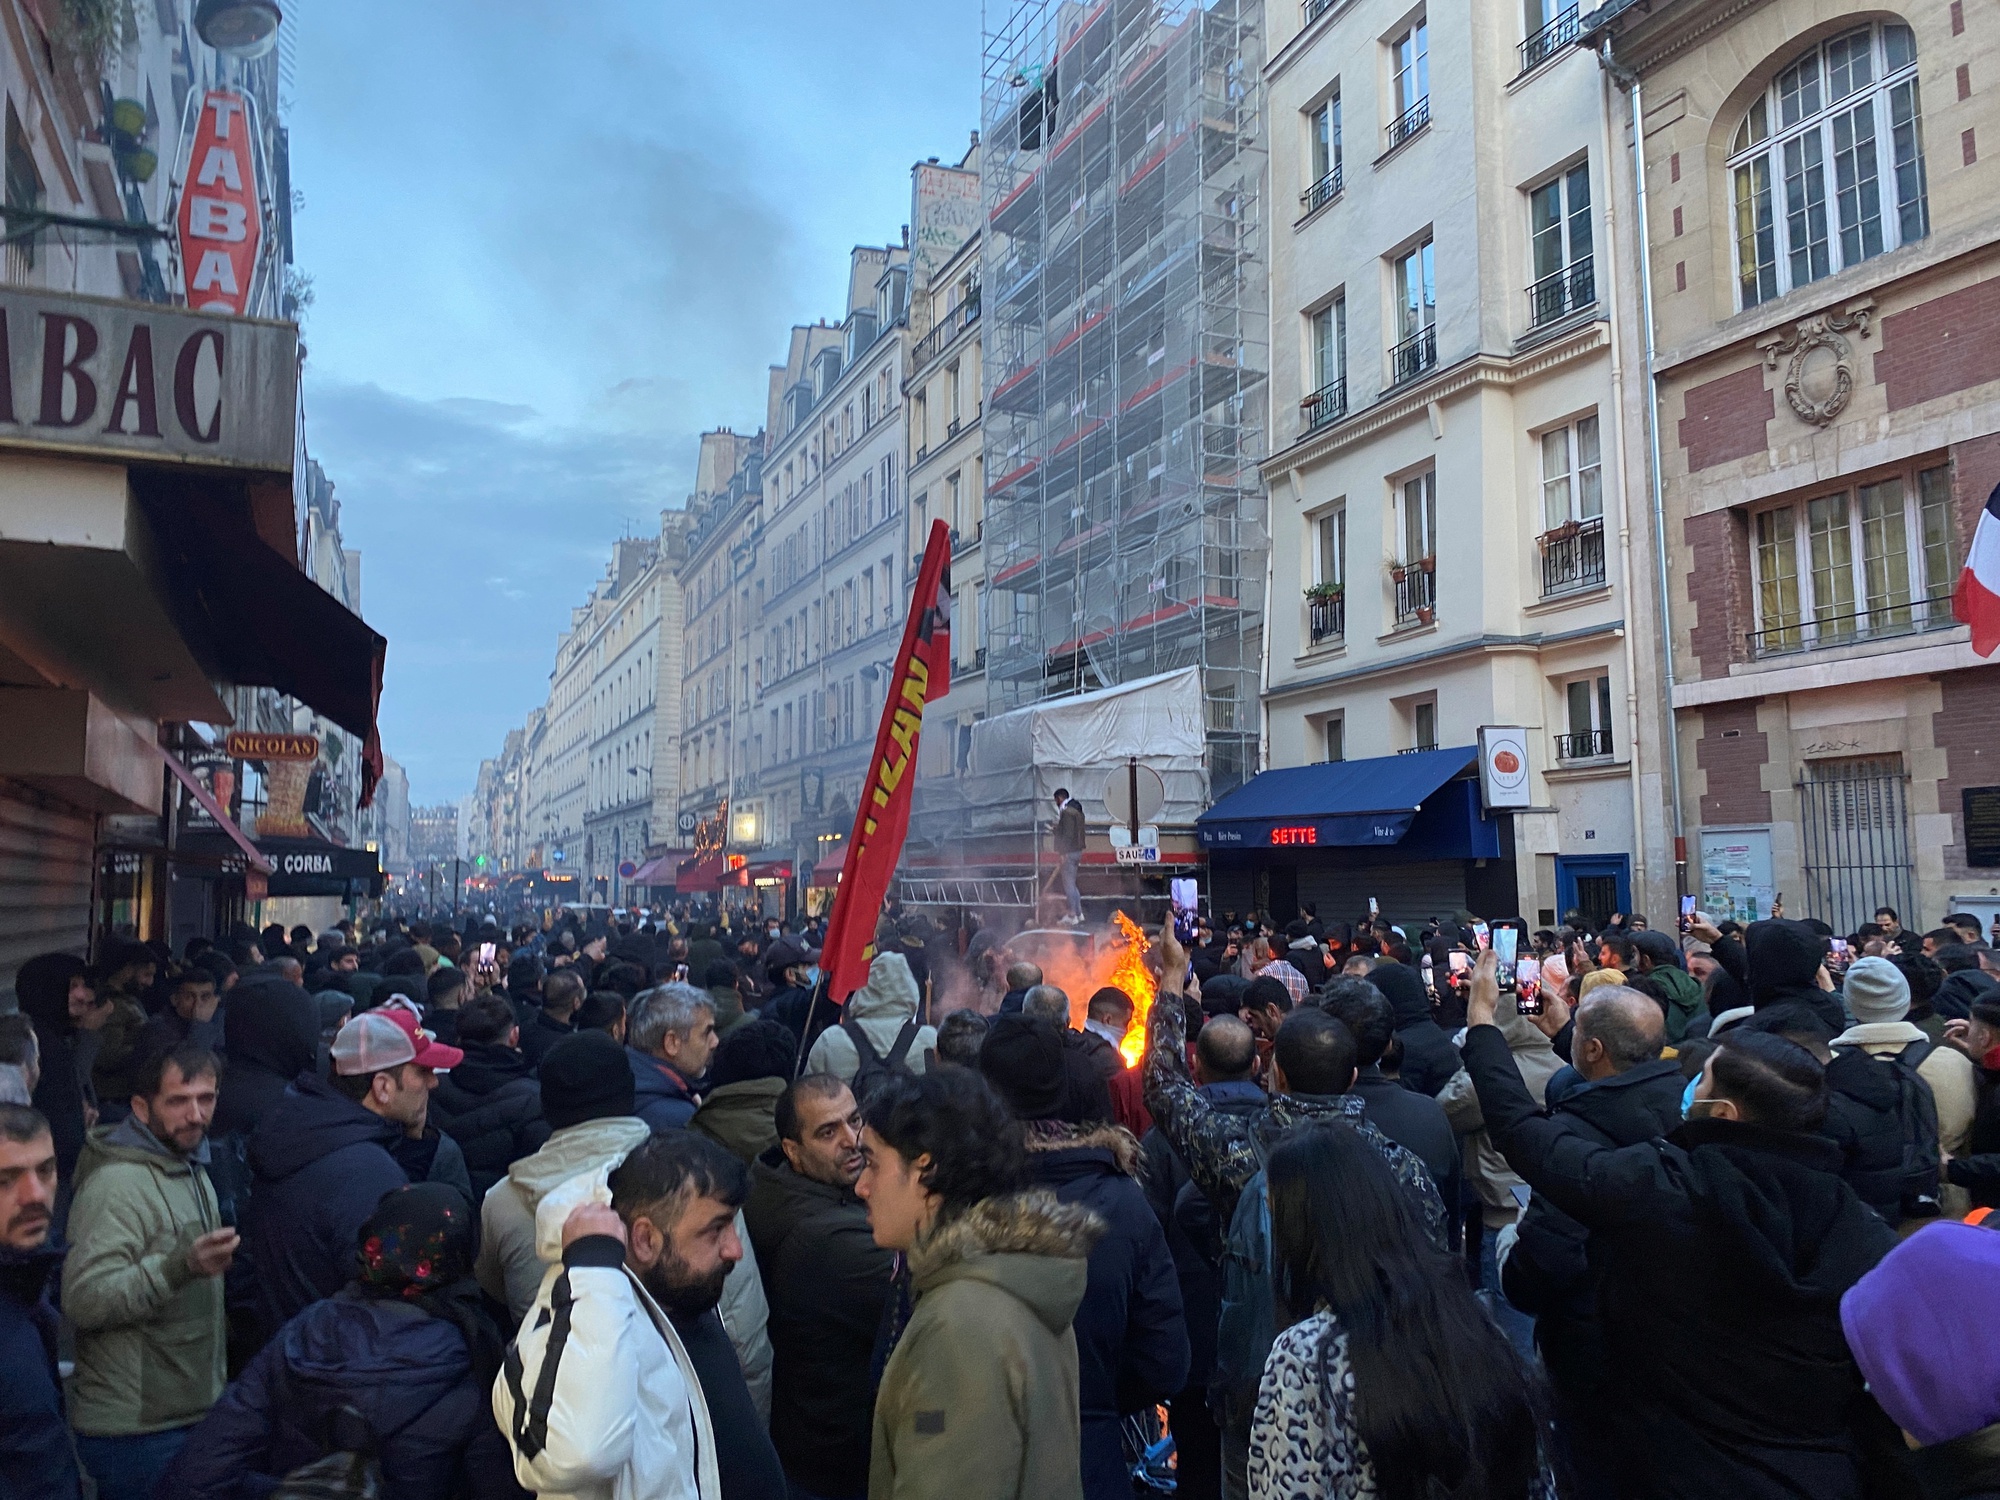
[[822, 520, 952, 1004]]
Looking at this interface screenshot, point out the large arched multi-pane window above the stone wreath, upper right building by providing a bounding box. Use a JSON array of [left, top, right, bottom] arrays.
[[1730, 24, 1930, 308]]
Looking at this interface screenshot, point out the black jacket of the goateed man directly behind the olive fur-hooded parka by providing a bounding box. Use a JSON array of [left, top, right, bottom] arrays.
[[744, 1152, 896, 1494]]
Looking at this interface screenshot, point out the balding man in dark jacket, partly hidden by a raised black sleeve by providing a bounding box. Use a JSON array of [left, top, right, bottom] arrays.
[[1500, 984, 1686, 1494]]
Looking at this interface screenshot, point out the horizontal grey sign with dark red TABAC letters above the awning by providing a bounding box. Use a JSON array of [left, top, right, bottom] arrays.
[[0, 286, 298, 474]]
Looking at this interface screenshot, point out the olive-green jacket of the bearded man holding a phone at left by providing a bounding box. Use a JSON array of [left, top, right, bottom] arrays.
[[62, 1116, 228, 1438]]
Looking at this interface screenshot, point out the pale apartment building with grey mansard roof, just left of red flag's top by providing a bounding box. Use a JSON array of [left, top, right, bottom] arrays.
[[730, 244, 910, 880]]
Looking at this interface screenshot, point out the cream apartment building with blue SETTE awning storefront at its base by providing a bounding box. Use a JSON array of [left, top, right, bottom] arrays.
[[1212, 0, 1666, 922]]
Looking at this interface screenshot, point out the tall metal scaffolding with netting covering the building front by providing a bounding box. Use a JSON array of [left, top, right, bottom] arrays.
[[980, 0, 1270, 796]]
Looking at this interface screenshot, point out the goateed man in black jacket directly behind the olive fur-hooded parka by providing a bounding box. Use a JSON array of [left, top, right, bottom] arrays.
[[744, 1072, 894, 1500]]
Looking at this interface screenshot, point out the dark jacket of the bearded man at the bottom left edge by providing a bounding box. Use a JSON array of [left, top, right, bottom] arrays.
[[0, 1246, 82, 1500]]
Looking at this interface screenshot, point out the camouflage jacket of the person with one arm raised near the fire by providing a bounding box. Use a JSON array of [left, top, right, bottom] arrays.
[[1146, 996, 1450, 1250]]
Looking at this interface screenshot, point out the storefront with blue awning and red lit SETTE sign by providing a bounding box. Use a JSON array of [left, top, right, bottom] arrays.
[[1196, 746, 1520, 926]]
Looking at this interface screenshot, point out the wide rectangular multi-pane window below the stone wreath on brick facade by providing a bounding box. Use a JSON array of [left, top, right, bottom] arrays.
[[1750, 466, 1956, 656]]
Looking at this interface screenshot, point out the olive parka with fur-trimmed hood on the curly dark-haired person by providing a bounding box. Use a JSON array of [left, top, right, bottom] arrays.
[[868, 1190, 1102, 1500]]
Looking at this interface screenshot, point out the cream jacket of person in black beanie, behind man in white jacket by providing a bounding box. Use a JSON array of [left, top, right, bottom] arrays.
[[476, 1116, 772, 1422]]
